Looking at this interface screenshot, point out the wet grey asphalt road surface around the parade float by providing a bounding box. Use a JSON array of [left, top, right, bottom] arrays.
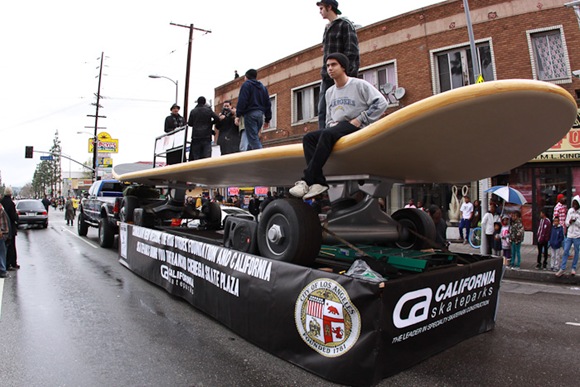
[[0, 211, 580, 386]]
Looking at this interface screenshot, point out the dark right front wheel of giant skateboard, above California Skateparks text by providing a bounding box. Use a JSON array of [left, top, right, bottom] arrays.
[[391, 208, 436, 250]]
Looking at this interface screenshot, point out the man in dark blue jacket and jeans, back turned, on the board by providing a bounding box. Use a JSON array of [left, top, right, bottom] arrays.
[[236, 69, 272, 152]]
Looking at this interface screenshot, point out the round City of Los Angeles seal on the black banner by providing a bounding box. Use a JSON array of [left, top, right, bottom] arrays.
[[294, 278, 360, 357]]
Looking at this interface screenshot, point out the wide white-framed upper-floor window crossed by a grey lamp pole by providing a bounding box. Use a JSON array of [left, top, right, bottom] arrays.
[[432, 41, 495, 94]]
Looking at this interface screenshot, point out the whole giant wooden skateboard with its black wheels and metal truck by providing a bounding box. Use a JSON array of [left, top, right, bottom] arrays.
[[118, 80, 577, 265]]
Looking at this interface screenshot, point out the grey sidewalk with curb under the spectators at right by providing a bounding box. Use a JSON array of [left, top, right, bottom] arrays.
[[449, 240, 580, 285]]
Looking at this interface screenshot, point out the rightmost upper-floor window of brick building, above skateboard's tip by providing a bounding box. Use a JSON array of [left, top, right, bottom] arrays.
[[528, 27, 570, 81]]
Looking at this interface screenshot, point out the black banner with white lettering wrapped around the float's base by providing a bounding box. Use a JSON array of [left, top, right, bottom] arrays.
[[119, 224, 502, 385]]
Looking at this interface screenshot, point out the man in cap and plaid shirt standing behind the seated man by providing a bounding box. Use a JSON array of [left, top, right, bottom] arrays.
[[316, 0, 360, 129]]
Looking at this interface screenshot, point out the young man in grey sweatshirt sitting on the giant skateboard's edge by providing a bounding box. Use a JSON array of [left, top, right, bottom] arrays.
[[290, 53, 387, 199]]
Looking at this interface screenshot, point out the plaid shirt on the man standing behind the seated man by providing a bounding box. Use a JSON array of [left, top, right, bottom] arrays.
[[320, 17, 360, 79]]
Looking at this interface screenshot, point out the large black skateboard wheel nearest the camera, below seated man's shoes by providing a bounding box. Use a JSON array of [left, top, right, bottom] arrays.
[[258, 199, 322, 265]]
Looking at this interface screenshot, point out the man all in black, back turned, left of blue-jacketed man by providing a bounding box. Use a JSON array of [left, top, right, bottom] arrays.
[[187, 97, 219, 161]]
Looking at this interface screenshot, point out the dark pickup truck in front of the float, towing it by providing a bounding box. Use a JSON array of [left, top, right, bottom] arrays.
[[77, 180, 125, 247]]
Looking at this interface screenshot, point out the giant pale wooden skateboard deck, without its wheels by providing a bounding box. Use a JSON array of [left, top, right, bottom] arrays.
[[113, 80, 577, 187]]
